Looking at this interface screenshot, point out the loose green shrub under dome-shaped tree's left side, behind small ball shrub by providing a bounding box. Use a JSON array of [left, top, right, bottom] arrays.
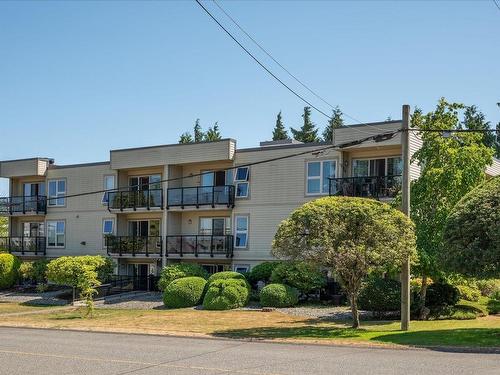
[[271, 262, 326, 294]]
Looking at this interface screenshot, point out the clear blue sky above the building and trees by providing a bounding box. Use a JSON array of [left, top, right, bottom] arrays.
[[0, 1, 500, 194]]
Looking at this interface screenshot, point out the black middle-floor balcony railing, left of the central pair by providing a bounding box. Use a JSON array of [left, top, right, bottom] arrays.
[[104, 236, 162, 257]]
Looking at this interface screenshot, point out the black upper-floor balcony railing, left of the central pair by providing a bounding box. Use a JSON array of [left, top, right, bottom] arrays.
[[108, 189, 163, 211]]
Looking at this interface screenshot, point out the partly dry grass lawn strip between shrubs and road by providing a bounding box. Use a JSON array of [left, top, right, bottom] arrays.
[[0, 309, 500, 347]]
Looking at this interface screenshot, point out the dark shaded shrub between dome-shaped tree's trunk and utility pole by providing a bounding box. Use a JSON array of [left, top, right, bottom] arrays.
[[358, 277, 401, 317]]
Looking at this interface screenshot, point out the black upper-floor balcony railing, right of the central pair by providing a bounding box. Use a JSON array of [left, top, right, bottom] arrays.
[[167, 185, 234, 209]]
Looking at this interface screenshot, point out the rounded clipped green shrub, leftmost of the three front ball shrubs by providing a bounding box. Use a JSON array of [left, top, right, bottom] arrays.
[[163, 276, 207, 308]]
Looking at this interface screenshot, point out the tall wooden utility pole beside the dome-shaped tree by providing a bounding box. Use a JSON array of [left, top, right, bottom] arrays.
[[401, 104, 410, 331]]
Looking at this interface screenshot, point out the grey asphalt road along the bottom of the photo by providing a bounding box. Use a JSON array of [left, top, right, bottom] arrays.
[[0, 328, 500, 375]]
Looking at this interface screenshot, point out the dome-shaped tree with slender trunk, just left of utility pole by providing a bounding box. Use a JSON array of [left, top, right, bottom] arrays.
[[272, 197, 415, 327]]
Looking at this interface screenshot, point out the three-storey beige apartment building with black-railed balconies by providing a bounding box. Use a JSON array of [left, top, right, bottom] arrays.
[[0, 121, 500, 276]]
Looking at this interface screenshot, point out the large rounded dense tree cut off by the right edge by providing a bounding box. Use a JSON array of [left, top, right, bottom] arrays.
[[441, 177, 500, 278]]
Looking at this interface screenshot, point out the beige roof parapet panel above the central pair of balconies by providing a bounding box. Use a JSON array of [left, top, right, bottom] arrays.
[[111, 139, 234, 169]]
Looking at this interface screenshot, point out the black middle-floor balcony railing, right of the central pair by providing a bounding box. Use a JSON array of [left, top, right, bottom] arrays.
[[167, 235, 234, 258]]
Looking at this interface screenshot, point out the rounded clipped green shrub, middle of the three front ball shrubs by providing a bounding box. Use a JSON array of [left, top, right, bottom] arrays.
[[203, 279, 250, 310]]
